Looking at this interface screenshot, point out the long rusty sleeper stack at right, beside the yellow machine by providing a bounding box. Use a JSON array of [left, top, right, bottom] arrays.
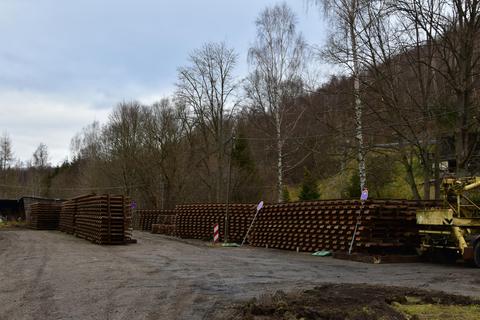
[[249, 200, 438, 253]]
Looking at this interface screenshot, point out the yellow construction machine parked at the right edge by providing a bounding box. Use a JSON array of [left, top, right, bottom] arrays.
[[417, 177, 480, 268]]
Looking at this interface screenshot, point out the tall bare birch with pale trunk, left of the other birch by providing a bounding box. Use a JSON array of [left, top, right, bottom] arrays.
[[245, 3, 306, 202]]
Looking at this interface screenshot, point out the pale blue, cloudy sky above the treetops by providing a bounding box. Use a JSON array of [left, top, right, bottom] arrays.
[[0, 0, 326, 165]]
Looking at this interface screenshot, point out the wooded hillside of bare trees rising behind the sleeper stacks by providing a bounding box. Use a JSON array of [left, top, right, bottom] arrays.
[[0, 0, 480, 209]]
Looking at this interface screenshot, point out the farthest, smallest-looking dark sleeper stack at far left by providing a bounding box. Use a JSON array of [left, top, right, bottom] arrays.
[[30, 202, 61, 230]]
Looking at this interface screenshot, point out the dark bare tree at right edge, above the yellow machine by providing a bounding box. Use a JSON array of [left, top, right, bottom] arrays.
[[395, 0, 480, 176]]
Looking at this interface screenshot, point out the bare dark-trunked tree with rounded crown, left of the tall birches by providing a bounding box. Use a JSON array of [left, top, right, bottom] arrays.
[[177, 43, 238, 202]]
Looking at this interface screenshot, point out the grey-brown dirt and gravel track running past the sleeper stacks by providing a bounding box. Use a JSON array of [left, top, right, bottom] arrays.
[[0, 230, 480, 320]]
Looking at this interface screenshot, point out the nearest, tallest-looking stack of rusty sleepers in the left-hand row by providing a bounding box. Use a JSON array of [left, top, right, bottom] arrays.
[[72, 194, 132, 244]]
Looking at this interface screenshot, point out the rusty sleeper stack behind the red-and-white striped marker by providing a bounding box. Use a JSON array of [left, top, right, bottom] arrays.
[[175, 204, 256, 242]]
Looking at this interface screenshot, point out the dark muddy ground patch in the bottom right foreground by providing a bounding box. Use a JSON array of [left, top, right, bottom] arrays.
[[210, 284, 480, 320]]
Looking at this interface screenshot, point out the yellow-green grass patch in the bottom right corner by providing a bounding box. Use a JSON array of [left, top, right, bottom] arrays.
[[393, 303, 480, 320]]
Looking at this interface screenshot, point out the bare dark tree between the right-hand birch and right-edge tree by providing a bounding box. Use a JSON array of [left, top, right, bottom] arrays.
[[344, 1, 438, 199]]
